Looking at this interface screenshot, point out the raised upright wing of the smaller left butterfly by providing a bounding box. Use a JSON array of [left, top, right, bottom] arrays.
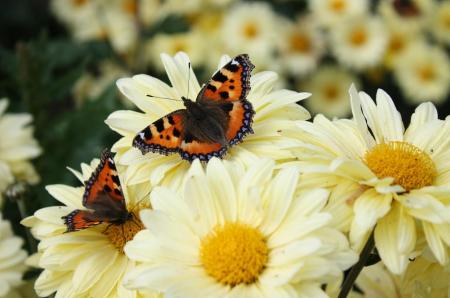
[[83, 150, 127, 213]]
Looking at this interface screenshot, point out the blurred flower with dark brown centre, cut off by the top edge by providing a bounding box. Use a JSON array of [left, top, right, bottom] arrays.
[[378, 0, 435, 34]]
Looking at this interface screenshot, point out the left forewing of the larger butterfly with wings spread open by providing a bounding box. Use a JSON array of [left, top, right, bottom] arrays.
[[133, 109, 186, 155]]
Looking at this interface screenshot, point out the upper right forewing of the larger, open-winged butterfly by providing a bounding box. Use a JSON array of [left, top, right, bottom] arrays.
[[196, 54, 255, 102]]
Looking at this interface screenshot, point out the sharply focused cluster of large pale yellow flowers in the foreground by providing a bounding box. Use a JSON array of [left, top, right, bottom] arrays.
[[22, 51, 450, 298]]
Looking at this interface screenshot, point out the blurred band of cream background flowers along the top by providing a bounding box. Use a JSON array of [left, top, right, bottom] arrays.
[[52, 0, 450, 117]]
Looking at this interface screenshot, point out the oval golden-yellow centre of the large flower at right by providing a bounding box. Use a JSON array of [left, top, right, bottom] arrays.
[[364, 141, 436, 191]]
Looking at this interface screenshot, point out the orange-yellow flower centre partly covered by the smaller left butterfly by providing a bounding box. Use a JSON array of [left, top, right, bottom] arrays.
[[102, 212, 144, 253]]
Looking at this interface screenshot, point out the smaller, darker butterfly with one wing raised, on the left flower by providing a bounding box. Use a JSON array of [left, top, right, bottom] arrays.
[[62, 150, 133, 232]]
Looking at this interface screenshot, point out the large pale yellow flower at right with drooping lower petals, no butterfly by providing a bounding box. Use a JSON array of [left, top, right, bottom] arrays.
[[297, 87, 450, 274]]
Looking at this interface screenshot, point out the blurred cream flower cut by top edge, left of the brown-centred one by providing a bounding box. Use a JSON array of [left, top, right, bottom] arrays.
[[308, 0, 369, 29]]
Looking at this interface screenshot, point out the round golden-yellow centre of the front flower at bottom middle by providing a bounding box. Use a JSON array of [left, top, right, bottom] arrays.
[[200, 223, 269, 287]]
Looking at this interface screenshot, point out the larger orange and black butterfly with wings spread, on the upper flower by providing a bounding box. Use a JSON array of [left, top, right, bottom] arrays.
[[133, 54, 255, 161]]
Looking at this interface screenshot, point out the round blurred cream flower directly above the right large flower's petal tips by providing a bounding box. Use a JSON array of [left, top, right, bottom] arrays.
[[330, 15, 388, 70]]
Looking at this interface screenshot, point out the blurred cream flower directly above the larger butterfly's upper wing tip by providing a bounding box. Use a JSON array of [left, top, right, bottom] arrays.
[[220, 2, 281, 70]]
